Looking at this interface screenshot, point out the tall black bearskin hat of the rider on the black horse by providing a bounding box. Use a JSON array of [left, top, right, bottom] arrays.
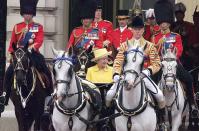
[[20, 0, 38, 16]]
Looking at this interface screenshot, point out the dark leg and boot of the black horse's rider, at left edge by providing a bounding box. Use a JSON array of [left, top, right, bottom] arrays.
[[0, 64, 14, 112]]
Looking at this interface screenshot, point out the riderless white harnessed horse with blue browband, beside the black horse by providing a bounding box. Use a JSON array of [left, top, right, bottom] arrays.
[[52, 49, 91, 131]]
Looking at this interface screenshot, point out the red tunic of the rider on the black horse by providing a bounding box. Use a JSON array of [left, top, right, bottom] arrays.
[[8, 22, 44, 53]]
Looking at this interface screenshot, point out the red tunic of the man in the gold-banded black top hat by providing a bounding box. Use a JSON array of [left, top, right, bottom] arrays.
[[109, 28, 133, 49]]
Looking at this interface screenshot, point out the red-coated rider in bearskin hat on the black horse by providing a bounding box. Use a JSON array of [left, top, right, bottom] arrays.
[[0, 0, 52, 112]]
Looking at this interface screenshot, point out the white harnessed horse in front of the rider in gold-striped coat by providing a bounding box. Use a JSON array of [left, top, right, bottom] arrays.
[[115, 46, 157, 131]]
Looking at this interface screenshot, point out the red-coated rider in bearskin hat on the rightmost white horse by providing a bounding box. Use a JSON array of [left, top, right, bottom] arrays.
[[154, 0, 197, 113]]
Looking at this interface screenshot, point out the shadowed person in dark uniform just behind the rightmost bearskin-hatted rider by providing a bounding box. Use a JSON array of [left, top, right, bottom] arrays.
[[171, 3, 193, 70]]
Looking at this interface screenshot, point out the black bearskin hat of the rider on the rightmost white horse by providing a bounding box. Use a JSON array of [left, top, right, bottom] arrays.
[[154, 0, 174, 24]]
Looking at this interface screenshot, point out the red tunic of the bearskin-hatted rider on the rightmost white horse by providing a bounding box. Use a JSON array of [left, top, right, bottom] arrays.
[[152, 32, 183, 59]]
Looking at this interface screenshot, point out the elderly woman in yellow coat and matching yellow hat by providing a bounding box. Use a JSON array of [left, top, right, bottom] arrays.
[[86, 48, 113, 83]]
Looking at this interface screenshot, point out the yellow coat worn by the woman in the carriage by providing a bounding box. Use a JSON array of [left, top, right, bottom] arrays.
[[86, 65, 113, 83]]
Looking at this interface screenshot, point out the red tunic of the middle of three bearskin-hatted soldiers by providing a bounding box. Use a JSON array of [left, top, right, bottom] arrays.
[[67, 26, 103, 49]]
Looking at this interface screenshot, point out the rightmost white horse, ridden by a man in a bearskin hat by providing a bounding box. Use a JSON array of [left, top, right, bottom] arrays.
[[159, 48, 188, 131]]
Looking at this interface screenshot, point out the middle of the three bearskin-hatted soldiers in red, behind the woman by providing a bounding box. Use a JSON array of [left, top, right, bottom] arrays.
[[67, 0, 103, 50]]
